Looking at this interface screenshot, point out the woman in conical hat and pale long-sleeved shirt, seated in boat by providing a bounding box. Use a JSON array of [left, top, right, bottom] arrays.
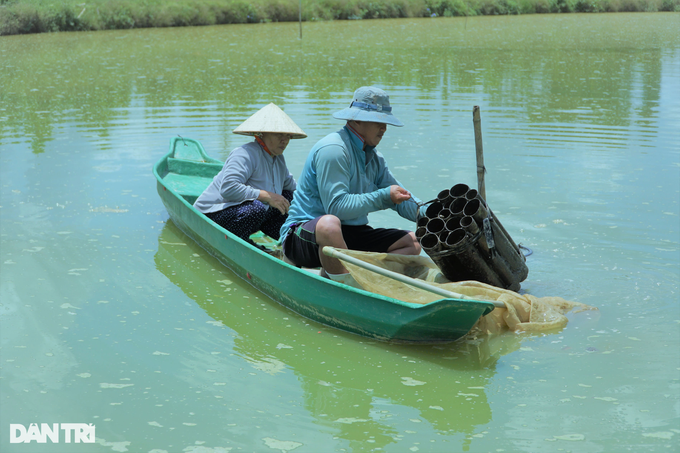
[[194, 103, 307, 248]]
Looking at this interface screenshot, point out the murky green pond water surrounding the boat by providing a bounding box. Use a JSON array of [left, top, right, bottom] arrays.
[[0, 13, 680, 453]]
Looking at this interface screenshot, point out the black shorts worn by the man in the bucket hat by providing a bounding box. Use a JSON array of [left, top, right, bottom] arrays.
[[283, 217, 409, 268]]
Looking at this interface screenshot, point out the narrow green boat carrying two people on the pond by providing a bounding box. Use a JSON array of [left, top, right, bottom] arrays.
[[153, 137, 494, 343]]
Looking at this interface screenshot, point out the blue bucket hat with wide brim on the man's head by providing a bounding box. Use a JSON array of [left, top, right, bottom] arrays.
[[333, 87, 404, 127]]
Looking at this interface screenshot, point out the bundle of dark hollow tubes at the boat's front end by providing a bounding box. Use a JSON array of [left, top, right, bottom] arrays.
[[416, 184, 529, 291]]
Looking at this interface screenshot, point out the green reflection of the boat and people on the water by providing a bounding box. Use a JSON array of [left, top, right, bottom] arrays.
[[155, 223, 520, 451]]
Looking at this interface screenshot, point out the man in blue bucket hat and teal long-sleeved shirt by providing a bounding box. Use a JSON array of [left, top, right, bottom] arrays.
[[281, 87, 424, 284]]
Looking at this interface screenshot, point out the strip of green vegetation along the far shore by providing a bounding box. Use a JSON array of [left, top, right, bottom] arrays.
[[0, 0, 680, 35]]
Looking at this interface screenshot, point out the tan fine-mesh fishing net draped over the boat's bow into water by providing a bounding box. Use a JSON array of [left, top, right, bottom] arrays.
[[343, 250, 597, 334]]
